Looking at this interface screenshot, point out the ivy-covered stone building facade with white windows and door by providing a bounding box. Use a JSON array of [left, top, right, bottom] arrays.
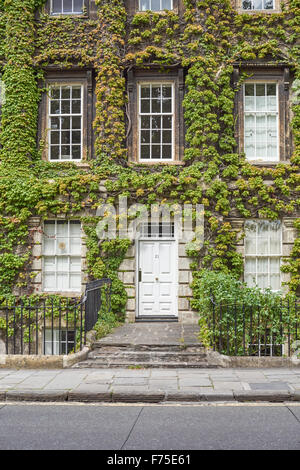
[[0, 0, 300, 342]]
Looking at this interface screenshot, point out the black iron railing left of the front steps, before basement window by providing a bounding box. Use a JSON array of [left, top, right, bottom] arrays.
[[0, 279, 112, 355]]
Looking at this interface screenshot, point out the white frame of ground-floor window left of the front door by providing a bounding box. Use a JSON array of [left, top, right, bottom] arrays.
[[42, 219, 82, 293]]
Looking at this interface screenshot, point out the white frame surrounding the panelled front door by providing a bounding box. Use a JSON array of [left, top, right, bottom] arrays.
[[135, 235, 179, 321]]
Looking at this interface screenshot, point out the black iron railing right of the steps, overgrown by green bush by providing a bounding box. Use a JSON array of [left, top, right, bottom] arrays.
[[208, 297, 300, 357]]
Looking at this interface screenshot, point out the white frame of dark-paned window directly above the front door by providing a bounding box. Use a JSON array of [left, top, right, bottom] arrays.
[[138, 81, 175, 164]]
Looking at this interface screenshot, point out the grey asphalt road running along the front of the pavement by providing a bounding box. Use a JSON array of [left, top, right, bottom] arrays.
[[0, 404, 300, 450]]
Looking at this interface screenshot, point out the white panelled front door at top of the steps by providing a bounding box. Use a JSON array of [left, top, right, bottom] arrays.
[[138, 240, 177, 317]]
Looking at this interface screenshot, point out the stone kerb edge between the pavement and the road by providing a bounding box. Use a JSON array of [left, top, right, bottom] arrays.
[[0, 389, 300, 403]]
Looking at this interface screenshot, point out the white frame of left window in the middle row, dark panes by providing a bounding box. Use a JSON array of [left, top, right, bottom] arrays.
[[47, 81, 84, 163]]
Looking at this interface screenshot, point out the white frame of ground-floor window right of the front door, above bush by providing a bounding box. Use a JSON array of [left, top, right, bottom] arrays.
[[244, 220, 283, 292]]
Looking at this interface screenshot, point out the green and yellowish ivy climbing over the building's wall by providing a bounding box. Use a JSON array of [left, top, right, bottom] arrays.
[[0, 0, 300, 313]]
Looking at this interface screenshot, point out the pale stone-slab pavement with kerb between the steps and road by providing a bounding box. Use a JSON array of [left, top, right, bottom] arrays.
[[0, 368, 300, 403]]
